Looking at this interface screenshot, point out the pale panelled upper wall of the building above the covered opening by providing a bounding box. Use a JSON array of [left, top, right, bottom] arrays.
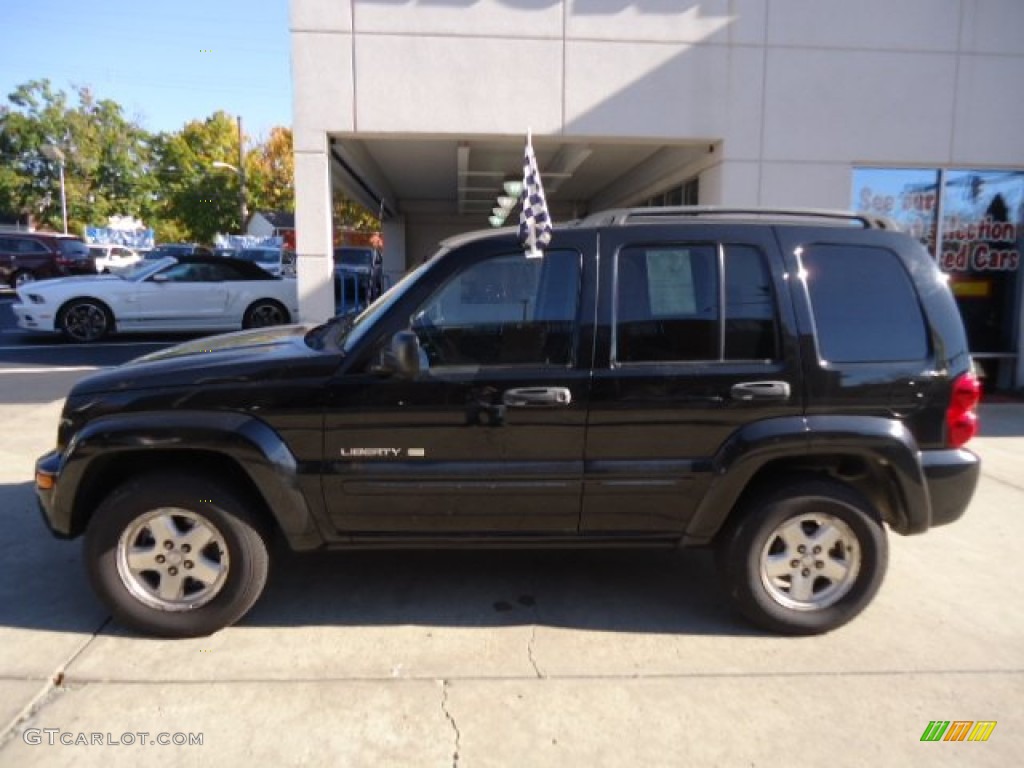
[[292, 0, 1024, 319]]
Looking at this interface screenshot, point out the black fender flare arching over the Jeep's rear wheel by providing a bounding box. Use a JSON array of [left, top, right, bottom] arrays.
[[683, 416, 931, 545]]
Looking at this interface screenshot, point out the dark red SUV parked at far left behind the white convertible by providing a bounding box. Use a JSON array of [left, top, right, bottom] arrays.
[[0, 231, 96, 288]]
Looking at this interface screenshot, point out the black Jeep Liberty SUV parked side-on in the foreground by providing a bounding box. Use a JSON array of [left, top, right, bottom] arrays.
[[36, 209, 980, 636]]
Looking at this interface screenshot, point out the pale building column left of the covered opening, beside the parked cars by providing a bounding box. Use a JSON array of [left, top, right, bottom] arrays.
[[295, 134, 335, 323]]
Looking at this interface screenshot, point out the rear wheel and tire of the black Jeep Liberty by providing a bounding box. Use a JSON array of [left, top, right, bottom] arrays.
[[717, 478, 889, 635]]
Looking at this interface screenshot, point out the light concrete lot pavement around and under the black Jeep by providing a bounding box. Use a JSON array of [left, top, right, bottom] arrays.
[[0, 294, 1024, 766]]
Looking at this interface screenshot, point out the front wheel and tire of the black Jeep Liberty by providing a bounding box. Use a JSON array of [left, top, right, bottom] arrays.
[[85, 472, 269, 637]]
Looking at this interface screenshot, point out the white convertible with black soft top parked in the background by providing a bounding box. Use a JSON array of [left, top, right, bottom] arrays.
[[13, 256, 299, 342]]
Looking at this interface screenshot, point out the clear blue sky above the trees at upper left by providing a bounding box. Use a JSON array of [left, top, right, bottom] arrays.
[[0, 0, 292, 137]]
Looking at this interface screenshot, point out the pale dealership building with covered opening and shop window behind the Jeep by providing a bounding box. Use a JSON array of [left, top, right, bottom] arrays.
[[291, 0, 1024, 387]]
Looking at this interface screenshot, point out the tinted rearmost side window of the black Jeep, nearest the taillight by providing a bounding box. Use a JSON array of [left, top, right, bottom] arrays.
[[801, 245, 929, 362]]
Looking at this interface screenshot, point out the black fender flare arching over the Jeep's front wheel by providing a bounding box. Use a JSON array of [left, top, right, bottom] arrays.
[[52, 411, 323, 550]]
